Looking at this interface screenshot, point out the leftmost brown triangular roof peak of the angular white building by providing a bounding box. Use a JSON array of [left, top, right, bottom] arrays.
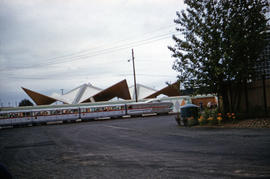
[[22, 87, 57, 105]]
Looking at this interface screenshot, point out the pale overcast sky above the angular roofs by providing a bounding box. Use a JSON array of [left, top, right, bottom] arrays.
[[0, 0, 184, 106]]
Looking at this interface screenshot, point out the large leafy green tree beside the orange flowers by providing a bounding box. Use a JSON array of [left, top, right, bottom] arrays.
[[168, 0, 269, 111]]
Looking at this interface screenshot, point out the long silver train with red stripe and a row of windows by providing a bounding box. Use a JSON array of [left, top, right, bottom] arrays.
[[0, 102, 173, 126]]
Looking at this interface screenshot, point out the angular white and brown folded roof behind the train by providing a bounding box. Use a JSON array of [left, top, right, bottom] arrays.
[[22, 80, 180, 105]]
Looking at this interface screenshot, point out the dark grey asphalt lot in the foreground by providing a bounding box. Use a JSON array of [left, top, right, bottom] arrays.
[[0, 115, 270, 179]]
